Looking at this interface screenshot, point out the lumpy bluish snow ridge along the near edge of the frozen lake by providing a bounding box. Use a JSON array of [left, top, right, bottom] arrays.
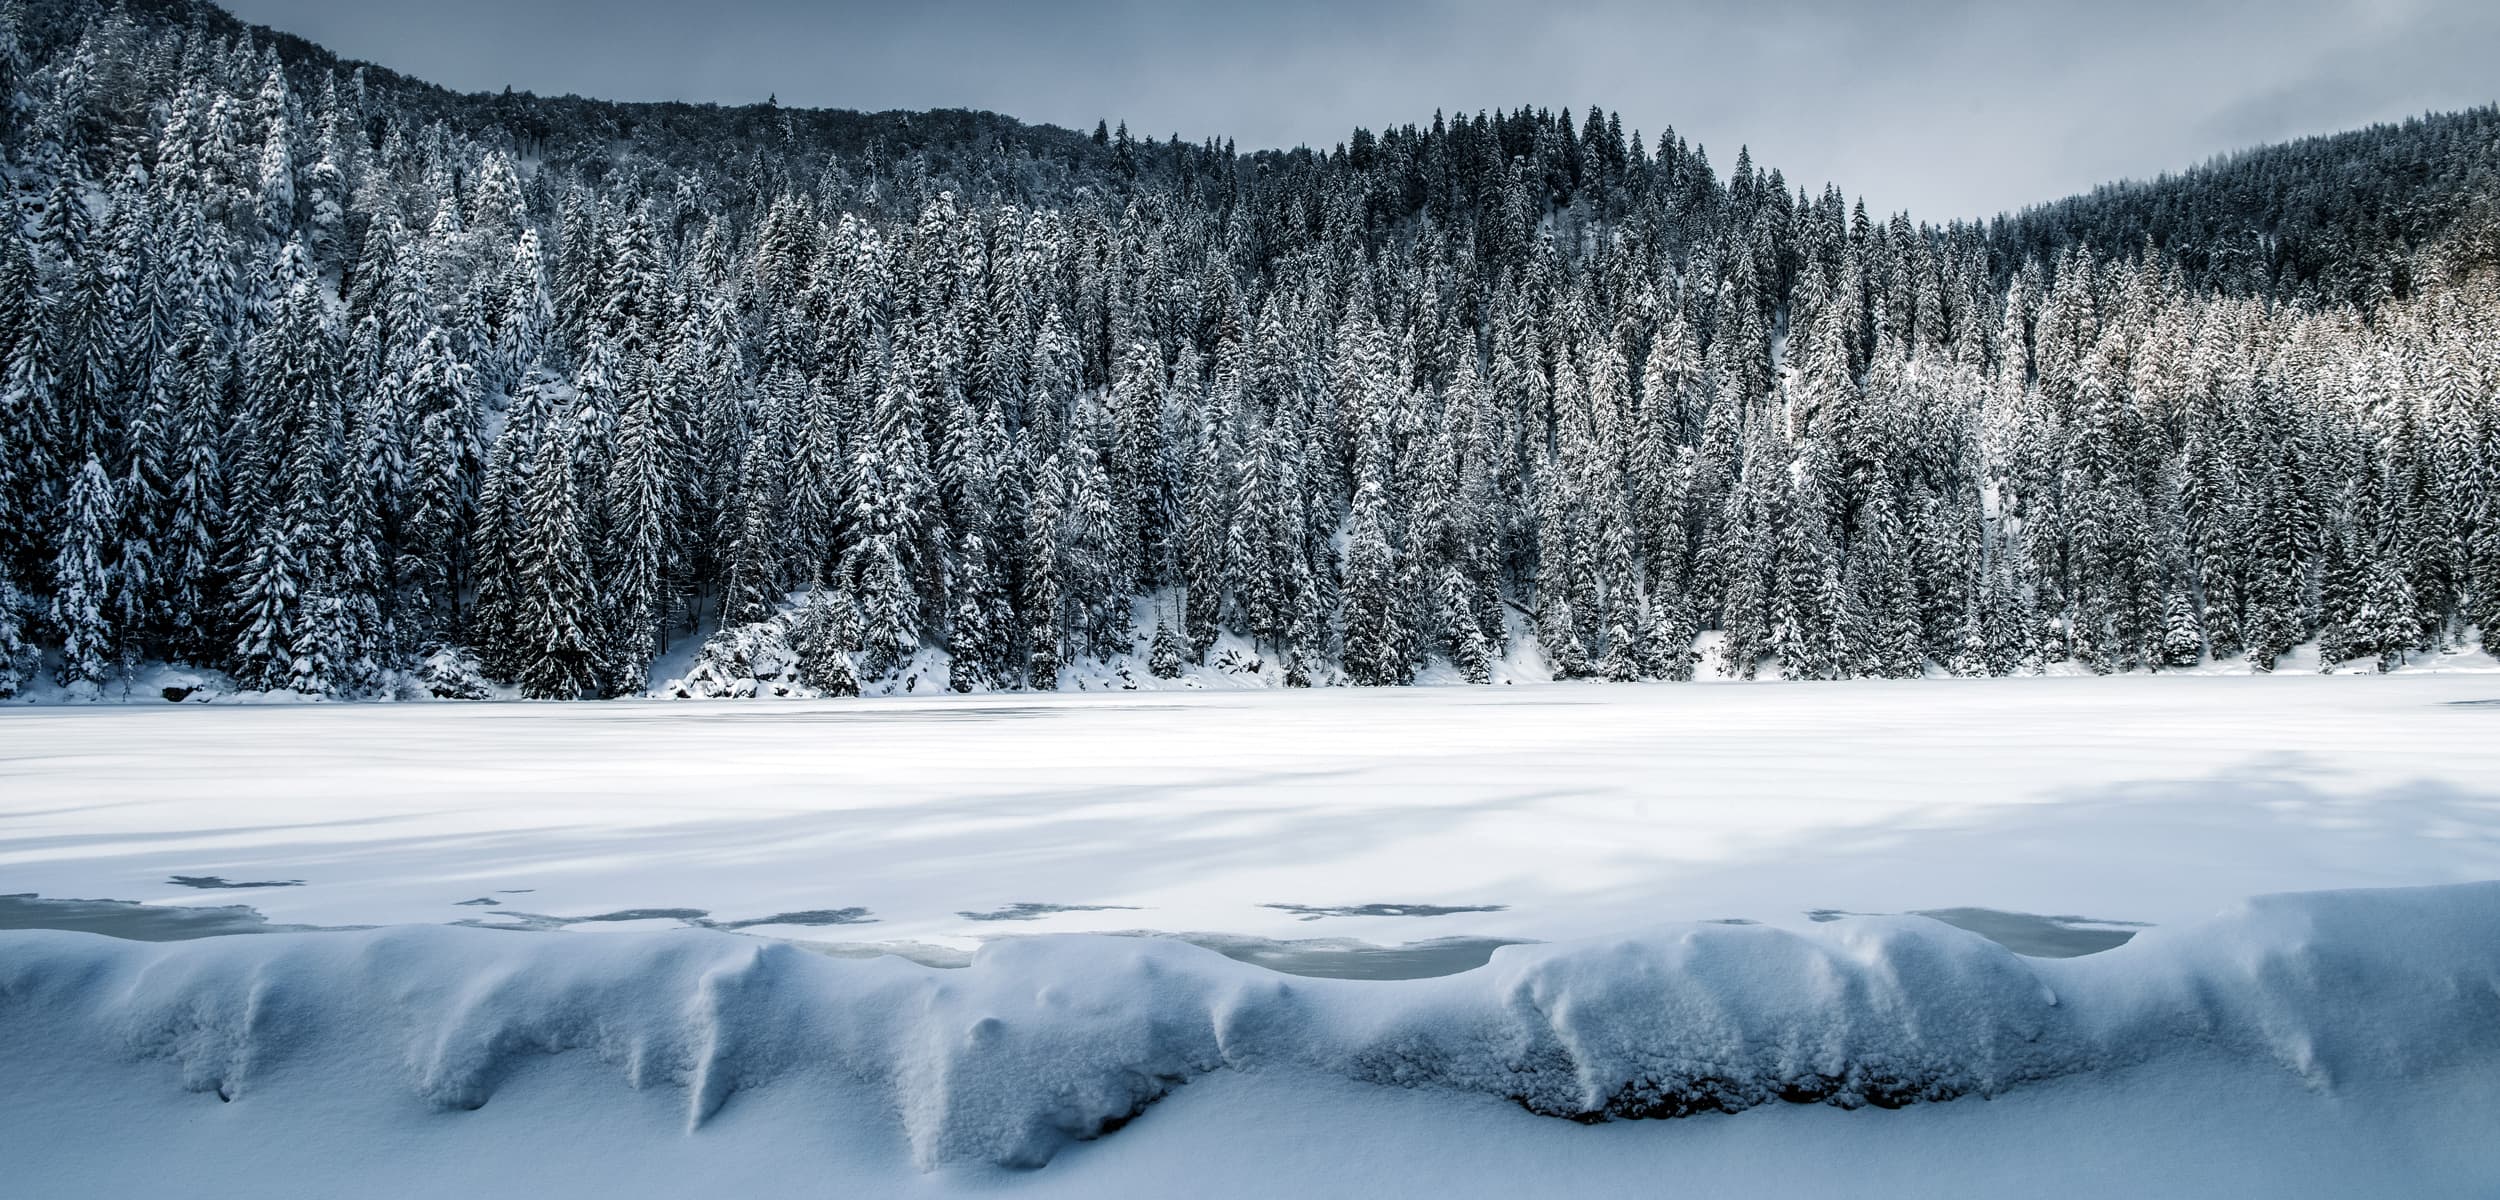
[[0, 883, 2500, 1168]]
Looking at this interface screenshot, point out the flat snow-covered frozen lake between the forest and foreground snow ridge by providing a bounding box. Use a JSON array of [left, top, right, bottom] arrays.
[[0, 675, 2500, 955]]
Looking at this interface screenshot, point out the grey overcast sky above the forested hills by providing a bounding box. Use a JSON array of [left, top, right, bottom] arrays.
[[225, 0, 2500, 220]]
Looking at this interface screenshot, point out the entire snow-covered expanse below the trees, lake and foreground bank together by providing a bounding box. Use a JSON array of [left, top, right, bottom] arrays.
[[0, 675, 2500, 1200]]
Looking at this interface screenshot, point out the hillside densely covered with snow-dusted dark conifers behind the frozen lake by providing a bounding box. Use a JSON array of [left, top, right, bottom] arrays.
[[0, 0, 2500, 698]]
